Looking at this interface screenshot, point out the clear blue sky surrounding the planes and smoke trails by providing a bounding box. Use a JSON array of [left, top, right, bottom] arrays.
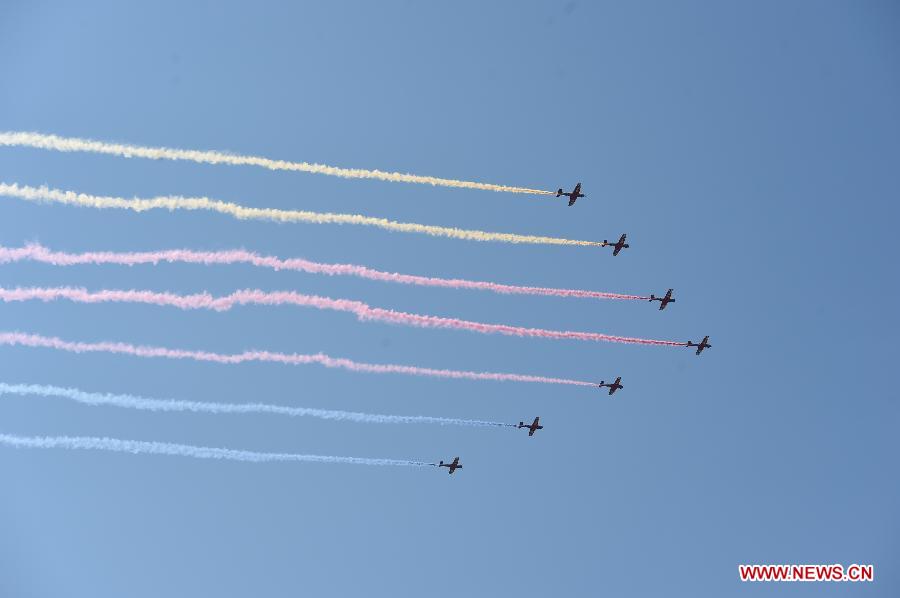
[[0, 1, 900, 598]]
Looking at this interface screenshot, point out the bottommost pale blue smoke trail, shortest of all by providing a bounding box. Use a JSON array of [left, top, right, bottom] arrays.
[[0, 434, 437, 467]]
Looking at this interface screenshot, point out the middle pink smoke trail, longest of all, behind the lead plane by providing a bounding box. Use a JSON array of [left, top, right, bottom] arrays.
[[0, 287, 684, 347]]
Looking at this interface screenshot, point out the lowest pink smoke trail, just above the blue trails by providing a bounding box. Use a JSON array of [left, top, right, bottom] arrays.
[[0, 332, 596, 386]]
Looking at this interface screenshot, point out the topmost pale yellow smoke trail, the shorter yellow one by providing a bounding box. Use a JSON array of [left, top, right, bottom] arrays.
[[0, 131, 554, 195]]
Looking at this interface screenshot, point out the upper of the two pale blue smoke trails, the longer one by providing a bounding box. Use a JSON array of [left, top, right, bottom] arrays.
[[0, 382, 516, 428]]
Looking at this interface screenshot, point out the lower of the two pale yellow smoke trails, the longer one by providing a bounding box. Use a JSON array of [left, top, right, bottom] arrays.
[[0, 183, 604, 247]]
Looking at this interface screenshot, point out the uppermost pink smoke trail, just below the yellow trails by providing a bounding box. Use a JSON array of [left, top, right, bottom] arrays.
[[0, 244, 650, 301]]
